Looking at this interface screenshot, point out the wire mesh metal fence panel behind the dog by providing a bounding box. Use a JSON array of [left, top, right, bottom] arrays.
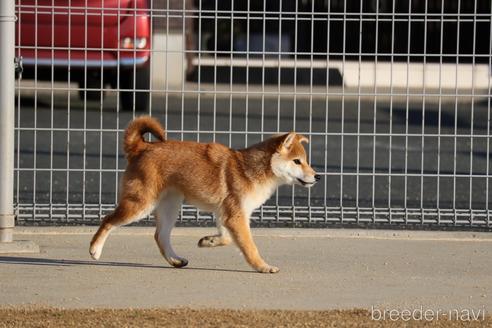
[[14, 0, 492, 230]]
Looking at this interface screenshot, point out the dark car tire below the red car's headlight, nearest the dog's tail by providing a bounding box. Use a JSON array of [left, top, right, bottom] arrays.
[[120, 66, 150, 112]]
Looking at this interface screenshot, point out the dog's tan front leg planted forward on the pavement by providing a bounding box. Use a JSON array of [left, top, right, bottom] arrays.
[[224, 213, 279, 273]]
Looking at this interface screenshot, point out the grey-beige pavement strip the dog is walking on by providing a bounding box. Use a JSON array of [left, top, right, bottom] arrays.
[[0, 227, 492, 315]]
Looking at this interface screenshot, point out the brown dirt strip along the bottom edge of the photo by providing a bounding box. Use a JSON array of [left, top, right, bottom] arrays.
[[0, 308, 492, 327]]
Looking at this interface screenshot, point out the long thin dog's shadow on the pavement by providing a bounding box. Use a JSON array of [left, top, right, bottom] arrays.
[[0, 256, 256, 273]]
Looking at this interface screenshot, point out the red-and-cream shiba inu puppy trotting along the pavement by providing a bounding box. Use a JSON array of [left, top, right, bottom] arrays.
[[89, 116, 320, 273]]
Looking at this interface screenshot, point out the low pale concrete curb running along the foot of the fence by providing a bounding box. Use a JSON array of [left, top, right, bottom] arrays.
[[14, 226, 492, 242]]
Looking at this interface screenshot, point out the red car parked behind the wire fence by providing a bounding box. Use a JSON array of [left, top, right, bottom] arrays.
[[16, 0, 151, 110]]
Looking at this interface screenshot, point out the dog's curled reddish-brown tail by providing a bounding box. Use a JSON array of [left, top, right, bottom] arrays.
[[123, 116, 165, 158]]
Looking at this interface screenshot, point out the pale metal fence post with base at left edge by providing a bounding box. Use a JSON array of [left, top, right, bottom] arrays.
[[0, 0, 39, 253]]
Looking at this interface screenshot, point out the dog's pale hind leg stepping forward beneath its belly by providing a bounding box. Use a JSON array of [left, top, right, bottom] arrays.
[[154, 192, 188, 268]]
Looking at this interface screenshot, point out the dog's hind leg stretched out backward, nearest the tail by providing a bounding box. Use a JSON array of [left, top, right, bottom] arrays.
[[89, 198, 155, 260]]
